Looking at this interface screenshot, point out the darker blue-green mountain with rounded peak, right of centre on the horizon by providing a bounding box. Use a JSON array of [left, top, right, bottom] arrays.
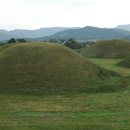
[[43, 26, 130, 40]]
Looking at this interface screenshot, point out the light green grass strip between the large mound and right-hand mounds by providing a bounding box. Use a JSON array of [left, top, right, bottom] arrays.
[[89, 58, 130, 76]]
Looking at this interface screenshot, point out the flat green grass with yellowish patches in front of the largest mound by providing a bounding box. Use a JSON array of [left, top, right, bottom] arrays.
[[0, 91, 130, 130]]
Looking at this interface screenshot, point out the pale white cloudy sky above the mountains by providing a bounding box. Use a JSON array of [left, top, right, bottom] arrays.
[[0, 0, 130, 30]]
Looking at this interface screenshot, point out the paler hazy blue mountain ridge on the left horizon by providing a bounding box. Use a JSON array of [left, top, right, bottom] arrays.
[[0, 27, 69, 40]]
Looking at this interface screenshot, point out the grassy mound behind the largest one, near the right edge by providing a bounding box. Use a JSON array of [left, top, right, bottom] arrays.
[[81, 40, 130, 58]]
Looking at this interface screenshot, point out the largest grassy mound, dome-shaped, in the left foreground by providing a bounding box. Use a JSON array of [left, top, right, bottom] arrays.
[[0, 43, 125, 95]]
